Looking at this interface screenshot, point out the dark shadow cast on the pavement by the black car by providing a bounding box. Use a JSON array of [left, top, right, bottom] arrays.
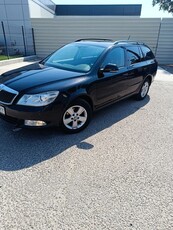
[[0, 96, 150, 171]]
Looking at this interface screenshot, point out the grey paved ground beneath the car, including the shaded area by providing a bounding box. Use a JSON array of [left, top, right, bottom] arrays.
[[0, 64, 173, 230]]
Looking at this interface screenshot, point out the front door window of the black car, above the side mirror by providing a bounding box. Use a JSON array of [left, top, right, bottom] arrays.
[[103, 47, 124, 68]]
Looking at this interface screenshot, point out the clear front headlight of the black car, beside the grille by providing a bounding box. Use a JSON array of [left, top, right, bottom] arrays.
[[17, 91, 59, 107]]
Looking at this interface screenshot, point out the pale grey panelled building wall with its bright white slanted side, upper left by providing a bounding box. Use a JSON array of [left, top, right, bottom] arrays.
[[0, 0, 54, 55]]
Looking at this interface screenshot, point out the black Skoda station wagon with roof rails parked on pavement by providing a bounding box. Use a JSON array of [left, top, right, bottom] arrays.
[[0, 39, 157, 133]]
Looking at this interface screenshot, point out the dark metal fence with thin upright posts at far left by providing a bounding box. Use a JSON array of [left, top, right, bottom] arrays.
[[0, 22, 36, 60]]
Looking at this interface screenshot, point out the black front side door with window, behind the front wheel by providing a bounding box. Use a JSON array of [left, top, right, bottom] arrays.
[[96, 47, 128, 106]]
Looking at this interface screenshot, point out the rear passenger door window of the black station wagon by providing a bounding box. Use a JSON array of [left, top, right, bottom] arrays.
[[127, 46, 142, 65]]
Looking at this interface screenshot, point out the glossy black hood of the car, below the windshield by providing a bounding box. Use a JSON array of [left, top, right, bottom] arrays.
[[0, 63, 86, 92]]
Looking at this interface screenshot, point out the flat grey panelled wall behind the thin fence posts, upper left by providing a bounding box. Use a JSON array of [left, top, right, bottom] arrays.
[[0, 0, 33, 54]]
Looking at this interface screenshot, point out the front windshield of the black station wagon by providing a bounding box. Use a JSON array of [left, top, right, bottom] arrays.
[[44, 43, 105, 72]]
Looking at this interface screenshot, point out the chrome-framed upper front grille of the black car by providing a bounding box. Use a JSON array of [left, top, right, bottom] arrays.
[[0, 84, 19, 105]]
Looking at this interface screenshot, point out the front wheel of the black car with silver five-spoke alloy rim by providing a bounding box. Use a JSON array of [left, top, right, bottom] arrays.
[[61, 99, 92, 134]]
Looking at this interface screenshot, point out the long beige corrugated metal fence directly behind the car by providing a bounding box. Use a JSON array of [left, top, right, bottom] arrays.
[[31, 16, 173, 64]]
